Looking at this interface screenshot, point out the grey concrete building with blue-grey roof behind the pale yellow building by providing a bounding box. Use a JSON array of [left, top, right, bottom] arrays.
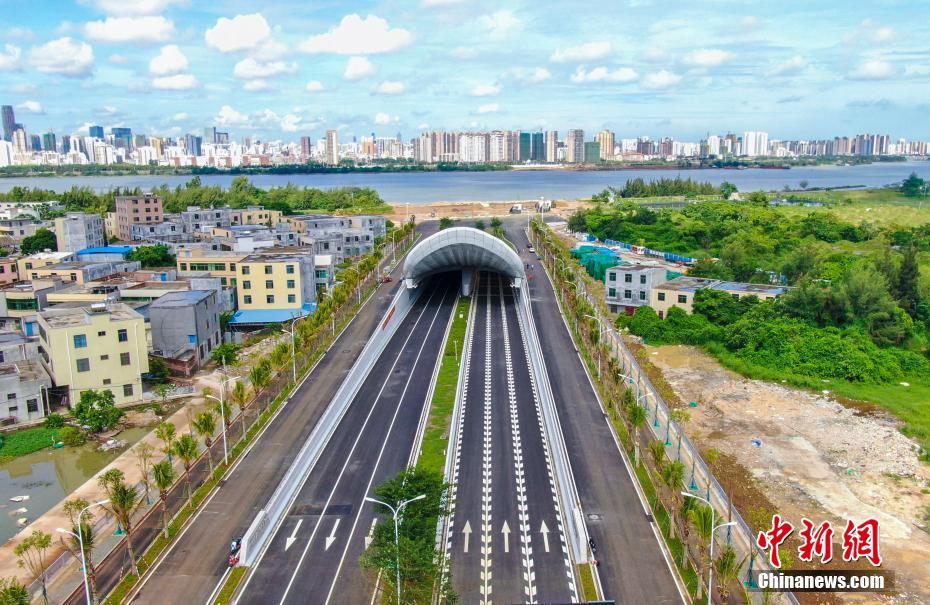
[[149, 290, 223, 369]]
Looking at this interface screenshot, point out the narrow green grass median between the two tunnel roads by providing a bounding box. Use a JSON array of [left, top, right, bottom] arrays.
[[417, 297, 471, 473]]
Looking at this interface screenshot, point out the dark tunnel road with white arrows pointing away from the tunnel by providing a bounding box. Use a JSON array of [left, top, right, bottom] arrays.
[[242, 274, 460, 604]]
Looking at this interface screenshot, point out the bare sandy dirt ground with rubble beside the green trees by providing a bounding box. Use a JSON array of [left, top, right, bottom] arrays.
[[647, 346, 930, 604]]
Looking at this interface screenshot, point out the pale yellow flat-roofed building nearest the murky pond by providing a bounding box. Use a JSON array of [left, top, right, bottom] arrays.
[[38, 303, 149, 405]]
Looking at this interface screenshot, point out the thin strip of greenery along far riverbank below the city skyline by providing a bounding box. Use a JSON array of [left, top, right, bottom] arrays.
[[0, 155, 908, 178]]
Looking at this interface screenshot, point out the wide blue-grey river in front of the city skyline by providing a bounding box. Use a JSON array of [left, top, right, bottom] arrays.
[[0, 161, 930, 204]]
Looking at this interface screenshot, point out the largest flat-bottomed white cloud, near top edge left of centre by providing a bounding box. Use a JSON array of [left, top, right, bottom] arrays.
[[300, 14, 413, 55]]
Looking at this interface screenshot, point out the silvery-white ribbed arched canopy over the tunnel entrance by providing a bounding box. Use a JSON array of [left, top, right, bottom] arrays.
[[404, 227, 526, 295]]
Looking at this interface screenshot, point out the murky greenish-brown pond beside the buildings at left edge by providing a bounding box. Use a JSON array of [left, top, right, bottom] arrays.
[[0, 427, 151, 542]]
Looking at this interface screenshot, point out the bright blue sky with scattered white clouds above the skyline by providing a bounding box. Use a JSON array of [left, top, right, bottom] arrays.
[[0, 0, 930, 140]]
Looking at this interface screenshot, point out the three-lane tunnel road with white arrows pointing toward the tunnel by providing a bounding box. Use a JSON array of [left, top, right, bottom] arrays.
[[447, 272, 577, 605]]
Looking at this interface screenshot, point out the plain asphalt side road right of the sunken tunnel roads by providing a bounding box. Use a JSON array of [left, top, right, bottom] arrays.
[[505, 218, 684, 604]]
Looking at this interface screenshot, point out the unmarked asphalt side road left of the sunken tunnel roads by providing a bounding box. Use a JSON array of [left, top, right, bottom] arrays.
[[132, 221, 437, 605]]
